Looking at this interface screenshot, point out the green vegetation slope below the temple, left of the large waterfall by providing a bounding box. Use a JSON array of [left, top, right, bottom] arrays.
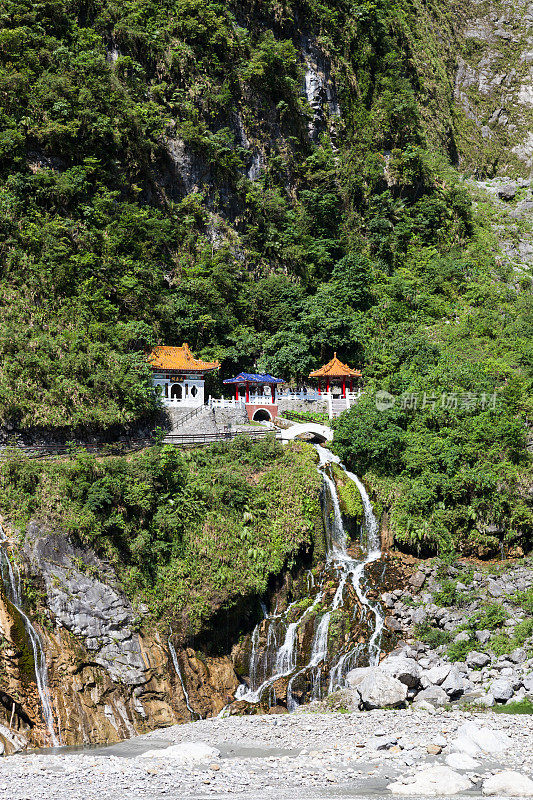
[[0, 439, 323, 636]]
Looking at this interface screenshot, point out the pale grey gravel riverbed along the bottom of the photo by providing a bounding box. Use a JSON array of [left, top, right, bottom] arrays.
[[4, 707, 533, 800]]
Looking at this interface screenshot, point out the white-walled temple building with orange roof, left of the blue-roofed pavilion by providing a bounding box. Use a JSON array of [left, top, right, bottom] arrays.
[[148, 344, 220, 408]]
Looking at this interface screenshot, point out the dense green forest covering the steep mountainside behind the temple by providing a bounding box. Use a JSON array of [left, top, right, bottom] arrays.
[[0, 0, 533, 554]]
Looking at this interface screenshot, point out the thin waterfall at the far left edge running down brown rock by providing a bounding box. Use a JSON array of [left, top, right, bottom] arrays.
[[0, 525, 61, 747]]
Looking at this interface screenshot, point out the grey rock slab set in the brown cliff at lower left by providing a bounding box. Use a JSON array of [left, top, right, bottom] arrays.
[[24, 523, 146, 684]]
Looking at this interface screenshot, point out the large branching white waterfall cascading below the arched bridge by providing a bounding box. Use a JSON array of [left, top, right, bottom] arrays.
[[235, 447, 384, 711]]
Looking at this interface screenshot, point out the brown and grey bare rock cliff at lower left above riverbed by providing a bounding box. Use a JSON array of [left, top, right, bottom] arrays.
[[0, 523, 238, 750]]
